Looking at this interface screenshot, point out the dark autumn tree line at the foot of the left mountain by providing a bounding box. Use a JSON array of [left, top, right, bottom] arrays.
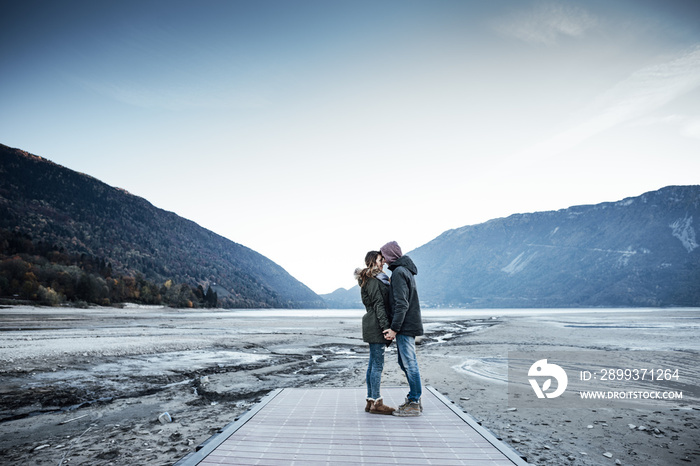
[[0, 229, 219, 308]]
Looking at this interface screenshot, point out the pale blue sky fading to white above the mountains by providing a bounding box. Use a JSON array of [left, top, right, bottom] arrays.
[[0, 0, 700, 294]]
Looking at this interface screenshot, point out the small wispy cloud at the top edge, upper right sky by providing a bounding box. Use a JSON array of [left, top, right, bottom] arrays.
[[494, 2, 598, 46]]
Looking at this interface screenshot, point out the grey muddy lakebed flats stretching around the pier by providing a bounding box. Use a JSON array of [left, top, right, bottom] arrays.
[[0, 307, 700, 466]]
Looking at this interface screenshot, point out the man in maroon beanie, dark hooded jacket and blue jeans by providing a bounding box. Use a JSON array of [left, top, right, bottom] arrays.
[[380, 241, 423, 416]]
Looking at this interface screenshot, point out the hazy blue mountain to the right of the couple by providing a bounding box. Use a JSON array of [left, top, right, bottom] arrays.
[[408, 186, 700, 307]]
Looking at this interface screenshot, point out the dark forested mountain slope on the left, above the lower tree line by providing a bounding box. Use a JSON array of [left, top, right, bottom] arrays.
[[0, 145, 325, 308]]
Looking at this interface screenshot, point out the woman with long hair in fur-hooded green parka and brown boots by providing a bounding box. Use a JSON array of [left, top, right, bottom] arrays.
[[355, 251, 395, 414]]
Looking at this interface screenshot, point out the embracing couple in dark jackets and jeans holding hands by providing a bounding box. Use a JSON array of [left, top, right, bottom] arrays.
[[355, 241, 423, 416]]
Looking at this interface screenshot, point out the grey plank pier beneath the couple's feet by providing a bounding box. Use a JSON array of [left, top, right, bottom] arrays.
[[175, 387, 527, 466]]
